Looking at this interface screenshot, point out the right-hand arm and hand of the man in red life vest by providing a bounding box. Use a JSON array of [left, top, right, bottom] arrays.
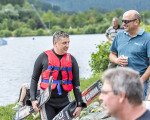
[[71, 56, 82, 118]]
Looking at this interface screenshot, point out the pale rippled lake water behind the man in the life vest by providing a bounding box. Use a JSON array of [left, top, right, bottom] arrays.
[[0, 34, 106, 106]]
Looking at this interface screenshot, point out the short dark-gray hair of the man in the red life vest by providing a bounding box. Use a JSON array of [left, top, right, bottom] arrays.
[[53, 31, 69, 43]]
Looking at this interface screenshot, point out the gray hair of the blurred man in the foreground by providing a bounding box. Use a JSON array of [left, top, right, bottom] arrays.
[[102, 67, 143, 105]]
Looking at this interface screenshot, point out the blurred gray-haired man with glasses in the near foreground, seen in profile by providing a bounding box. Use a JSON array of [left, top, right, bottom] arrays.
[[99, 67, 150, 120]]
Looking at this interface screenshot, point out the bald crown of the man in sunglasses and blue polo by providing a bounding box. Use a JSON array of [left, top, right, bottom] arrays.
[[123, 10, 141, 24]]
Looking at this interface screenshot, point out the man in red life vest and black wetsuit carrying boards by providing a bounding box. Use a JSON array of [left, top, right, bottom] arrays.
[[30, 31, 82, 120]]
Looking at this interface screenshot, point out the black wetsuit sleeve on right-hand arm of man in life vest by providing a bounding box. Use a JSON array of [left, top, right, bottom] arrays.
[[71, 56, 82, 107]]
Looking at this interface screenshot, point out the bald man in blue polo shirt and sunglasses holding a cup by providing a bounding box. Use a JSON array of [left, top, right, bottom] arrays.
[[109, 10, 150, 100]]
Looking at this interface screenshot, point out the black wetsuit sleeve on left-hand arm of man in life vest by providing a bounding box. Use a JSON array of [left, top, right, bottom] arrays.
[[30, 53, 47, 101]]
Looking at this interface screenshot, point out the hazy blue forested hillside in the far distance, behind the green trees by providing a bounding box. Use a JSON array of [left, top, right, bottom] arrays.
[[41, 0, 150, 12]]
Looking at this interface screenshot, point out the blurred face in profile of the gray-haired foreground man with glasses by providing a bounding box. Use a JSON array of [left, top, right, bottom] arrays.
[[99, 81, 119, 116]]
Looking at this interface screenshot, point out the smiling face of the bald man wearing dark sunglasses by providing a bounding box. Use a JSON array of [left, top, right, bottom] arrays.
[[122, 13, 136, 33]]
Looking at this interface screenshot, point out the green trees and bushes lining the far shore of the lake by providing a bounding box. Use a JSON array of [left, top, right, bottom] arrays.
[[0, 0, 150, 37]]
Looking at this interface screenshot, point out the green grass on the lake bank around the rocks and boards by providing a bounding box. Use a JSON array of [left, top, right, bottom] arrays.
[[0, 74, 101, 120]]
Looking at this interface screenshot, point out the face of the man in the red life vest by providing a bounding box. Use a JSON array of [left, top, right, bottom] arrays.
[[54, 37, 70, 55]]
